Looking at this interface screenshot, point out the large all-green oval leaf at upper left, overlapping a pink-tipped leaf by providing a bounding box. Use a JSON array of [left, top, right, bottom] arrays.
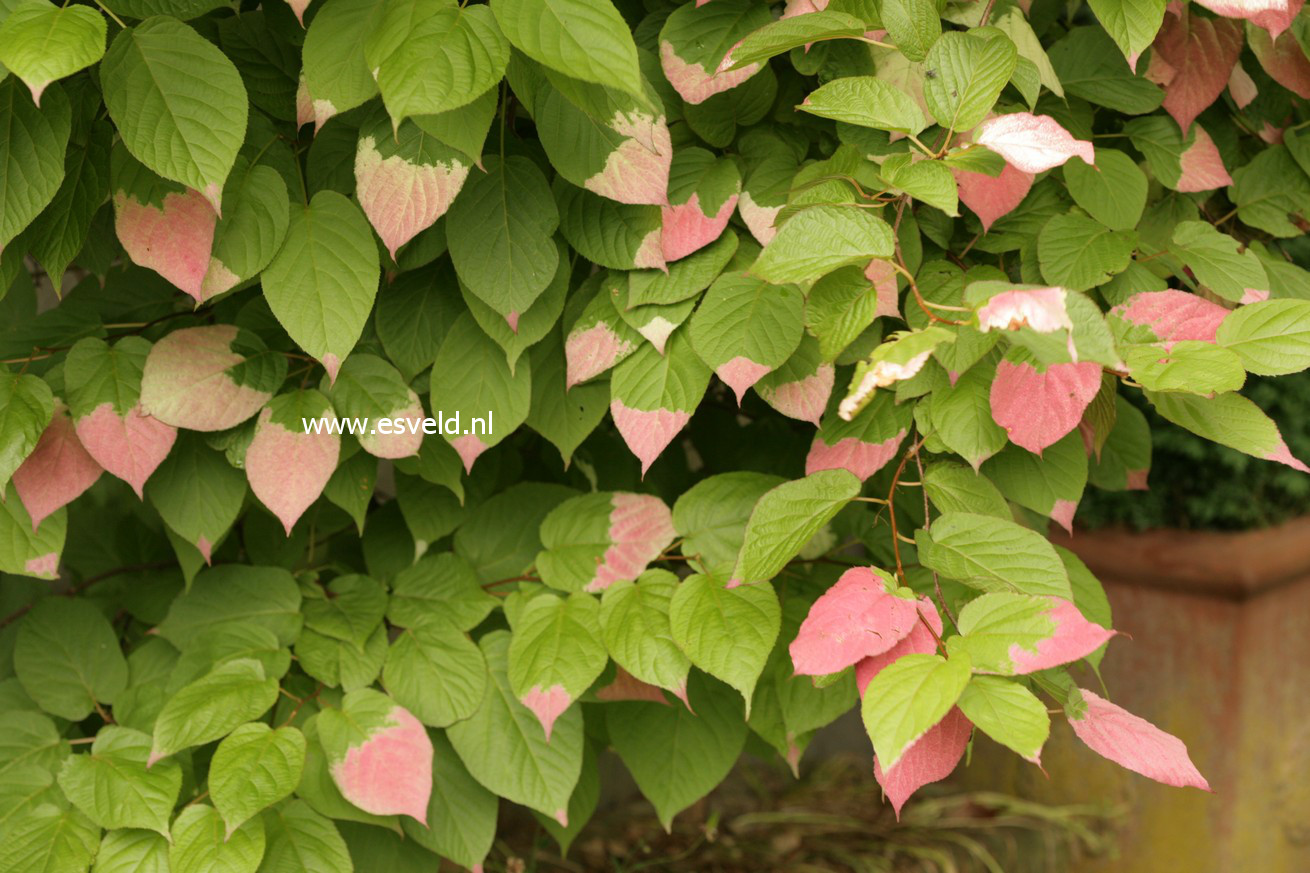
[[100, 16, 248, 210]]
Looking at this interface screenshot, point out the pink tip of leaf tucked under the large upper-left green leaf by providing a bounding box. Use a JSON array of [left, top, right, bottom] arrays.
[[114, 189, 217, 303]]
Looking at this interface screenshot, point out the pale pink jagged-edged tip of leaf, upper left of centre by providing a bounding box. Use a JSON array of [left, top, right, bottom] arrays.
[[355, 136, 469, 261]]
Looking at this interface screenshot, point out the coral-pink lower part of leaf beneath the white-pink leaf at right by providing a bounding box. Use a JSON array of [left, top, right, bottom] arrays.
[[990, 360, 1100, 455]]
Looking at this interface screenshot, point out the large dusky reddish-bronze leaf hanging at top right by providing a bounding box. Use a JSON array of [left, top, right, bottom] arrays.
[[1154, 10, 1243, 134]]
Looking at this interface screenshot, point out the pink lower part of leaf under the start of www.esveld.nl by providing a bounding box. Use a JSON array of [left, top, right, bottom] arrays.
[[245, 406, 341, 536]]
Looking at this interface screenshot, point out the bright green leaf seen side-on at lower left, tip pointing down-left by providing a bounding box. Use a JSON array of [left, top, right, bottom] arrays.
[[149, 658, 278, 760]]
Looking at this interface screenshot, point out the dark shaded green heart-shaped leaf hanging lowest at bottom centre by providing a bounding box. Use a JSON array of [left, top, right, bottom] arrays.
[[605, 668, 747, 830]]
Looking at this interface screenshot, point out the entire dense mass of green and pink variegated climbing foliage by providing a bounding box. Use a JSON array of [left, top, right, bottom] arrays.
[[0, 0, 1310, 873]]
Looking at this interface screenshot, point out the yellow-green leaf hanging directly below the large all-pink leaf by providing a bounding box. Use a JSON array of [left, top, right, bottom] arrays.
[[861, 650, 971, 773]]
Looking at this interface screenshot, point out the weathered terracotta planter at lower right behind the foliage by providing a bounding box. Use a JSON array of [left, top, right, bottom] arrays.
[[965, 518, 1310, 873]]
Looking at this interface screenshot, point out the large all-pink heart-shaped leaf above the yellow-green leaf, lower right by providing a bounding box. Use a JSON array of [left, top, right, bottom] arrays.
[[787, 566, 918, 676]]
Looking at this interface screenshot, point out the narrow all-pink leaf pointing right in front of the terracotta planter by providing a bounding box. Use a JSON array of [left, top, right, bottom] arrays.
[[1069, 688, 1210, 792]]
